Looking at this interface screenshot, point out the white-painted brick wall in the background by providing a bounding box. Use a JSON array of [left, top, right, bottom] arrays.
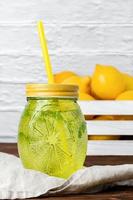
[[0, 0, 133, 140]]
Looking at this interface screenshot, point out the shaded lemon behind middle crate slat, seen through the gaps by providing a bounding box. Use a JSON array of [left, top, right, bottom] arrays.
[[88, 115, 120, 140]]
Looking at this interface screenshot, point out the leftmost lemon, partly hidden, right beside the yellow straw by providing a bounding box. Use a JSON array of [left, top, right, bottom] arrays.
[[54, 71, 76, 83]]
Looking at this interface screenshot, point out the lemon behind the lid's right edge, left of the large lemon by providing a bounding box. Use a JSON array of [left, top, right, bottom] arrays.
[[62, 75, 91, 93]]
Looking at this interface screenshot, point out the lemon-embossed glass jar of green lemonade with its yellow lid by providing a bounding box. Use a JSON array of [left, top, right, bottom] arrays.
[[18, 84, 87, 178]]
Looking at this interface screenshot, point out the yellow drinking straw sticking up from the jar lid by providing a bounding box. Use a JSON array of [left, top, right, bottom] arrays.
[[38, 21, 54, 84]]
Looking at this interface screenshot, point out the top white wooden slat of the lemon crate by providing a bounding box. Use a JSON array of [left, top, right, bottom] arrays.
[[78, 100, 133, 115]]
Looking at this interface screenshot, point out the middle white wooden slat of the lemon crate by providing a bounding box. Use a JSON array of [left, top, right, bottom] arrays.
[[86, 120, 133, 135]]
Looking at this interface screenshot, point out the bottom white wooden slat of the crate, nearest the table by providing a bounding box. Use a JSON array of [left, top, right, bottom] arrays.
[[87, 140, 133, 156]]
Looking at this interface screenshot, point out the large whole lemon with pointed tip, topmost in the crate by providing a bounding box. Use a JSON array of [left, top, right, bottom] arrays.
[[91, 64, 126, 100]]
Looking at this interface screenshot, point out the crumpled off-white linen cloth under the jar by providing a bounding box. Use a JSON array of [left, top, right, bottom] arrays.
[[0, 153, 133, 199]]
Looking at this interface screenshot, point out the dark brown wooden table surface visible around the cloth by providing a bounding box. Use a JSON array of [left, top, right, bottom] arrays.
[[0, 143, 133, 200]]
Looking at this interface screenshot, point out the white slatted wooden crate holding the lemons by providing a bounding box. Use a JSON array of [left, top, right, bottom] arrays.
[[79, 100, 133, 155]]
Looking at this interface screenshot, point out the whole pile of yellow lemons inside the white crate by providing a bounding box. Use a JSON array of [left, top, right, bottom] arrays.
[[54, 64, 133, 140]]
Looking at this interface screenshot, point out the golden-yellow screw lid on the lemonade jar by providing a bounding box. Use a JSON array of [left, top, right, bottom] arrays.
[[26, 84, 78, 98]]
